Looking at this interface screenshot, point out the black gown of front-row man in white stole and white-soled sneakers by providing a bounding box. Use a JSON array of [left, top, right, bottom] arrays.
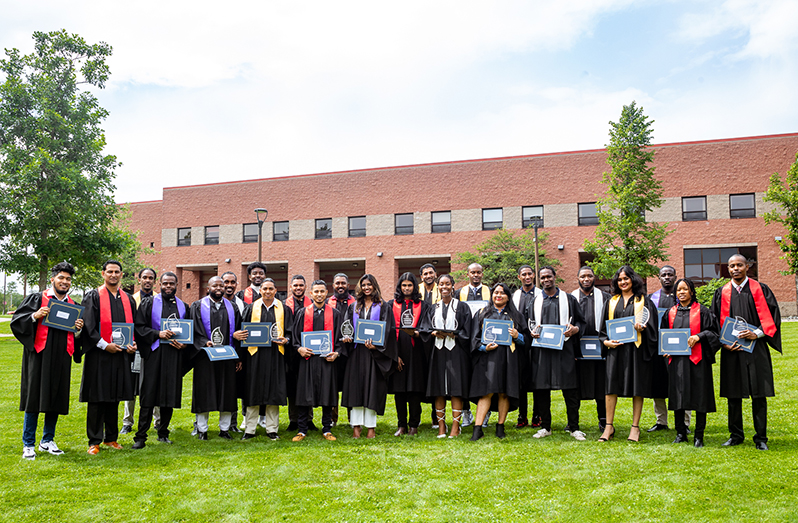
[[527, 289, 585, 390]]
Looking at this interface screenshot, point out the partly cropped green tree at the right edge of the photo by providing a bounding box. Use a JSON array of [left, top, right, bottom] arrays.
[[764, 153, 798, 312]]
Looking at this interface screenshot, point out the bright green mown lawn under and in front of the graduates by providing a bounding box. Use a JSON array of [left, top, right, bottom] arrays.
[[0, 323, 798, 522]]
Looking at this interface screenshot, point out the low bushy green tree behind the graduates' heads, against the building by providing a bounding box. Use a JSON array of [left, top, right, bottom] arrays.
[[452, 228, 560, 287]]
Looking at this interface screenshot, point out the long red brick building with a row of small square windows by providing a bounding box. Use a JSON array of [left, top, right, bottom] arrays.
[[130, 133, 798, 314]]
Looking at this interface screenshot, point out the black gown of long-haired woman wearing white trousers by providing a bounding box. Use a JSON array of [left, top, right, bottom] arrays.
[[341, 302, 398, 416]]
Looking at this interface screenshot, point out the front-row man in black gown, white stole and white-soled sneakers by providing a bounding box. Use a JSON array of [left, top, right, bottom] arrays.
[[527, 267, 585, 441]]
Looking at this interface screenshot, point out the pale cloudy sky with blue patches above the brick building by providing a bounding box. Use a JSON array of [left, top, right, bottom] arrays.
[[0, 0, 798, 202]]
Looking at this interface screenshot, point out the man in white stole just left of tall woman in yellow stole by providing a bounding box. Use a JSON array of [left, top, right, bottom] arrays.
[[571, 265, 611, 432]]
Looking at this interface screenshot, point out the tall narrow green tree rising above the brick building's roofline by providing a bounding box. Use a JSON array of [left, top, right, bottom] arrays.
[[584, 102, 669, 278]]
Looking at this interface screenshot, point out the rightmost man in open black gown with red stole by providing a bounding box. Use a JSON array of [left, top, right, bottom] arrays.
[[712, 254, 781, 450]]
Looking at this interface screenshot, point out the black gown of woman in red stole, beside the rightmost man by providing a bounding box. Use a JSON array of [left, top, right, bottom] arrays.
[[660, 305, 720, 412]]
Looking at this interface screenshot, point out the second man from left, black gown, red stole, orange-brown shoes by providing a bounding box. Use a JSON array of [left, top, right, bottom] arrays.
[[80, 260, 137, 455]]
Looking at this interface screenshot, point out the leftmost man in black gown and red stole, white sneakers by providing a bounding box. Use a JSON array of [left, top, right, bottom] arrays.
[[11, 262, 83, 459]]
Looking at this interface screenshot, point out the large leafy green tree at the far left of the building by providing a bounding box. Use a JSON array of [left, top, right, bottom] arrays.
[[0, 30, 138, 289]]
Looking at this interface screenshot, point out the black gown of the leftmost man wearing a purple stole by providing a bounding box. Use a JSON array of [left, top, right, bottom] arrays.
[[136, 297, 191, 409]]
